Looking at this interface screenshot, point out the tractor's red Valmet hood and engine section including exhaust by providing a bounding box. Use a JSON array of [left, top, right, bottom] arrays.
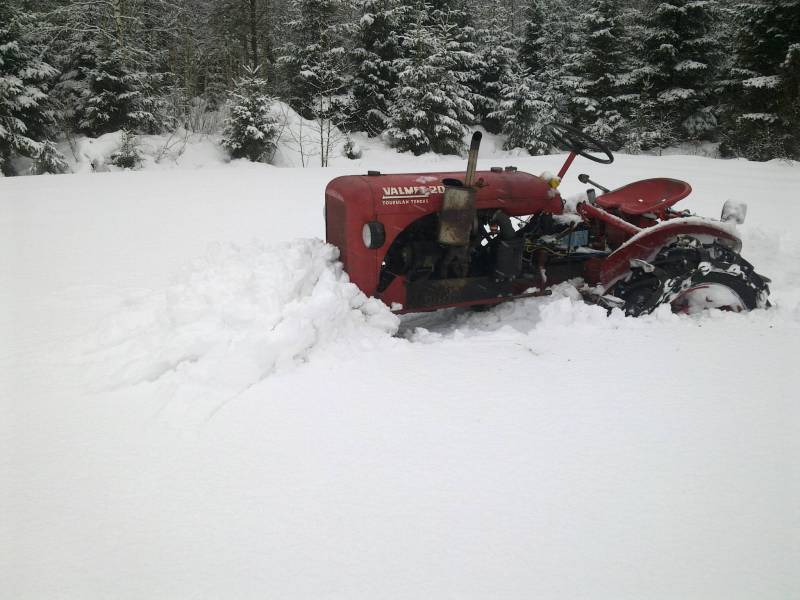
[[325, 134, 588, 312]]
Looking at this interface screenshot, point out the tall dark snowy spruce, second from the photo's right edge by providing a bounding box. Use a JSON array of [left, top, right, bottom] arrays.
[[641, 0, 721, 140]]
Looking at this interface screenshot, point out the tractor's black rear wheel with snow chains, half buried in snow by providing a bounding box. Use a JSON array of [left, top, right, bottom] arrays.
[[612, 237, 770, 316]]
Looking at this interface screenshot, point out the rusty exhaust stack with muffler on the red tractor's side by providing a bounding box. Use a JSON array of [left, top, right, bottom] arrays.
[[438, 131, 483, 247]]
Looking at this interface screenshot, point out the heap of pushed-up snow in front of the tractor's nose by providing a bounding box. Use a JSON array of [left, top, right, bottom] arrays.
[[82, 240, 398, 393]]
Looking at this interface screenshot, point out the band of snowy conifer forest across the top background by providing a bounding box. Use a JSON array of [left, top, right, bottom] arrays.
[[0, 0, 800, 175]]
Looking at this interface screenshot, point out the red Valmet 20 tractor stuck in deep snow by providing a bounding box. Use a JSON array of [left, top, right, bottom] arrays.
[[325, 123, 769, 315]]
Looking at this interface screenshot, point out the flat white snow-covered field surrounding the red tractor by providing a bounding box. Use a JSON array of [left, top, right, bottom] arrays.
[[0, 148, 800, 600]]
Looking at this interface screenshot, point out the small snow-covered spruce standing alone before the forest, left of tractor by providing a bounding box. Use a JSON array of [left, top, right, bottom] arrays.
[[222, 69, 279, 162]]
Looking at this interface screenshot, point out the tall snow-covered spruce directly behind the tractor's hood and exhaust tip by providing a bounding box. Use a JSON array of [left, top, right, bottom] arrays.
[[387, 12, 474, 155]]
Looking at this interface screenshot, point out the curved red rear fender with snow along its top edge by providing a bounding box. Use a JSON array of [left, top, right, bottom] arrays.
[[599, 217, 742, 289]]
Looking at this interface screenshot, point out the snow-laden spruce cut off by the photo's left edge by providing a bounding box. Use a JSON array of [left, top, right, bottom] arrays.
[[0, 2, 56, 175]]
